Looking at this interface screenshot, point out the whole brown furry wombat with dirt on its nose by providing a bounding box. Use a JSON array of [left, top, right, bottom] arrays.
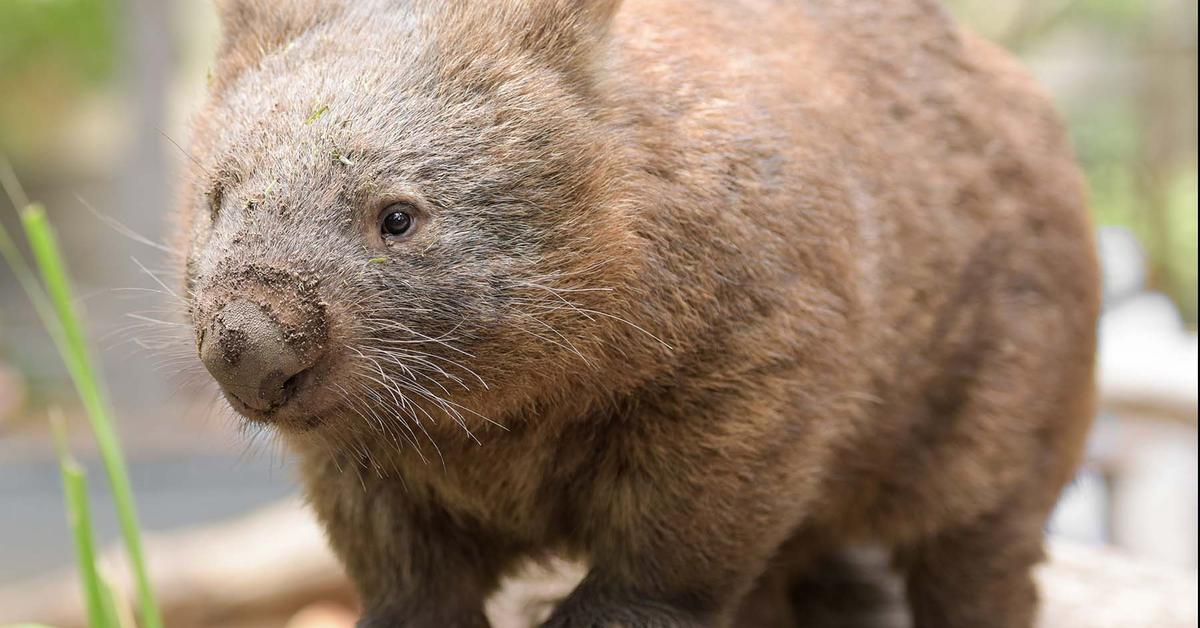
[[179, 0, 1098, 628]]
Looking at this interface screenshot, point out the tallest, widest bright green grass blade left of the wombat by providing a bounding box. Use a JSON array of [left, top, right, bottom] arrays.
[[22, 205, 162, 628]]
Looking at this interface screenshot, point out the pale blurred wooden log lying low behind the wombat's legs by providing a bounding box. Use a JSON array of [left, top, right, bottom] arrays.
[[0, 501, 1196, 628]]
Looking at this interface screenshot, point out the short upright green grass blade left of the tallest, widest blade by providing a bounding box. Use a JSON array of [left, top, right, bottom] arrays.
[[54, 421, 120, 628]]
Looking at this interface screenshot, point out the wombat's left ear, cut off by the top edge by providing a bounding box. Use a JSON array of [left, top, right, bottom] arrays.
[[214, 0, 342, 91]]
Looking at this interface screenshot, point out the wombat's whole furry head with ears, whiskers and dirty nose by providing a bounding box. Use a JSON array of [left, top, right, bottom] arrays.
[[182, 0, 637, 438]]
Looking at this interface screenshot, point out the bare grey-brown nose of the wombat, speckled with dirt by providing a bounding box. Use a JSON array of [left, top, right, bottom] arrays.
[[200, 299, 314, 412]]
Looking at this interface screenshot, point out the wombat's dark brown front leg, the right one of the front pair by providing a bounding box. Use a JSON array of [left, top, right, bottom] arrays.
[[544, 407, 805, 628]]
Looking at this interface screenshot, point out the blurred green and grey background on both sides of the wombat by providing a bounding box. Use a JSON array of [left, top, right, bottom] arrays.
[[0, 0, 1198, 624]]
